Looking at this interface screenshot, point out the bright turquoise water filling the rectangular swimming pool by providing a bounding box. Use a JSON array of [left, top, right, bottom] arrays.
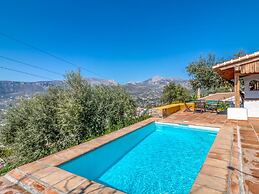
[[60, 123, 217, 193]]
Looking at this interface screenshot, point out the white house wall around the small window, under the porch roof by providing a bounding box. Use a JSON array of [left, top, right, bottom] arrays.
[[244, 74, 259, 117]]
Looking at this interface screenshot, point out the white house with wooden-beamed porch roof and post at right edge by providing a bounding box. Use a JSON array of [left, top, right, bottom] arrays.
[[213, 52, 259, 120]]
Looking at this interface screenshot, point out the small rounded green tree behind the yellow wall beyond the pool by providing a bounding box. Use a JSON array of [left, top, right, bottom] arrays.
[[161, 82, 191, 104]]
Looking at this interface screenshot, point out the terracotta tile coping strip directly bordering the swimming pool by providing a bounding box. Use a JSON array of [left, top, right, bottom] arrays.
[[4, 118, 234, 194]]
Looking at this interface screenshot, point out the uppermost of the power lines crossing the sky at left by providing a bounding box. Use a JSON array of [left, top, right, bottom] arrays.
[[0, 32, 106, 79]]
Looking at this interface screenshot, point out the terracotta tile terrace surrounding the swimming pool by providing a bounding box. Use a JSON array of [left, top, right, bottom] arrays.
[[0, 112, 259, 194]]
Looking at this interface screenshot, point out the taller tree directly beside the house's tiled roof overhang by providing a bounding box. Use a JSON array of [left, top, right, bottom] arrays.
[[186, 54, 232, 93]]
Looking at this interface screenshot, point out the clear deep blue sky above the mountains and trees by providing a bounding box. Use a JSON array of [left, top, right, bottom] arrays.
[[0, 0, 259, 83]]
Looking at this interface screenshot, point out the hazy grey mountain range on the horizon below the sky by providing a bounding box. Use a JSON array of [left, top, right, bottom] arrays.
[[0, 76, 190, 107]]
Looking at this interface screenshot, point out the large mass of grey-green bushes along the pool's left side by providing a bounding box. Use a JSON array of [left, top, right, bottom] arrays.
[[0, 72, 142, 174]]
